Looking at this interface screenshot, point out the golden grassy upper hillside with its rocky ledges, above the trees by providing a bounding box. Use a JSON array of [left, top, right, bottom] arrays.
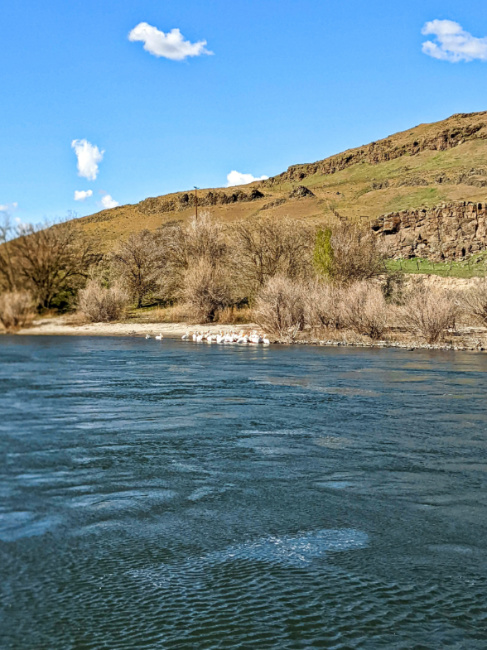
[[79, 111, 487, 247]]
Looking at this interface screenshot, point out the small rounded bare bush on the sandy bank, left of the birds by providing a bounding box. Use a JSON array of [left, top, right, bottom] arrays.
[[79, 280, 129, 323]]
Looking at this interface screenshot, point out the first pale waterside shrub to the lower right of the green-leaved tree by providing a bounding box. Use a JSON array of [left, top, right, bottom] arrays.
[[342, 281, 387, 340]]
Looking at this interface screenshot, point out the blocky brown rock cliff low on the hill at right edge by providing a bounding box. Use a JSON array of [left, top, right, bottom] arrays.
[[372, 201, 487, 261]]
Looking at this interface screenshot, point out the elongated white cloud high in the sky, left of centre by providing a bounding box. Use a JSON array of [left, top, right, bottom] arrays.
[[129, 23, 213, 61]]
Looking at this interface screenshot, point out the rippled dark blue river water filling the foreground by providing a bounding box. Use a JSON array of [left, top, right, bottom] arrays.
[[0, 337, 487, 650]]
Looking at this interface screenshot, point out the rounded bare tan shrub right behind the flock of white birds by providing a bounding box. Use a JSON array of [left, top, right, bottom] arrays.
[[181, 258, 232, 323]]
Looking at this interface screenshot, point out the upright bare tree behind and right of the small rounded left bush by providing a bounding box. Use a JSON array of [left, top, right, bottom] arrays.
[[112, 230, 163, 308]]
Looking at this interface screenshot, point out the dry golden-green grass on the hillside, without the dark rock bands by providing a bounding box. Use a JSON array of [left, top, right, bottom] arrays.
[[74, 114, 487, 249]]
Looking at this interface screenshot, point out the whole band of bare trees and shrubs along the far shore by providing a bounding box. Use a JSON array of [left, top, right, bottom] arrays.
[[0, 212, 487, 350]]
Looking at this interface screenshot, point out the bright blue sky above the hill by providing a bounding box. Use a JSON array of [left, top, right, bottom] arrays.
[[0, 0, 487, 221]]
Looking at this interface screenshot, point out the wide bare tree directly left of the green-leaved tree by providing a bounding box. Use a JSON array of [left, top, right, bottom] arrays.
[[233, 217, 313, 292]]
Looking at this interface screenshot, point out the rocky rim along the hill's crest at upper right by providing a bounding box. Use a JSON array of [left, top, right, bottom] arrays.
[[263, 112, 487, 187]]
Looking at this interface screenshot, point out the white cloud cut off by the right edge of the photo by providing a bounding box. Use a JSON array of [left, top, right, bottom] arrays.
[[422, 20, 487, 63]]
